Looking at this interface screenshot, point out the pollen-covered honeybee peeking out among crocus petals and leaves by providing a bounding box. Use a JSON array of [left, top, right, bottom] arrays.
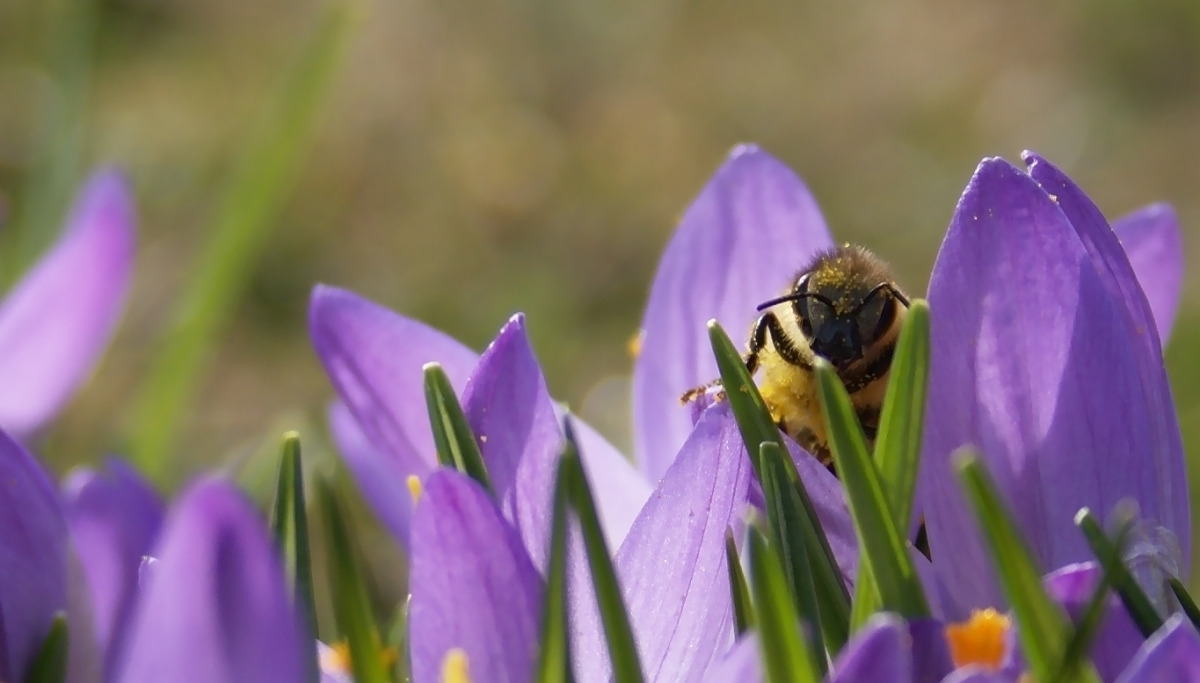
[[683, 244, 908, 471]]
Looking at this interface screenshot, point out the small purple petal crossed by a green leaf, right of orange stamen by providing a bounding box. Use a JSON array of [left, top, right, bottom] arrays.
[[1043, 563, 1145, 681]]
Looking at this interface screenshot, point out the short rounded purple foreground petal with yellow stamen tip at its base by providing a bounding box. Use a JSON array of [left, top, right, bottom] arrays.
[[409, 469, 548, 683]]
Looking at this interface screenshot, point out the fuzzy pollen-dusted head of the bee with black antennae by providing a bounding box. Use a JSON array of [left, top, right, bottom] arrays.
[[758, 248, 908, 370]]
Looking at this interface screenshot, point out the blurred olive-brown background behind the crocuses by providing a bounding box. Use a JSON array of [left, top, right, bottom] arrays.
[[0, 0, 1200, 592]]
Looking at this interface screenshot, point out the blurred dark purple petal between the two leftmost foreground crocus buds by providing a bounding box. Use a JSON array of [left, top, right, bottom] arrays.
[[62, 459, 163, 676]]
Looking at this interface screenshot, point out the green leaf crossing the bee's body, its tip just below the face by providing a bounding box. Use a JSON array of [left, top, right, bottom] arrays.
[[812, 358, 929, 618]]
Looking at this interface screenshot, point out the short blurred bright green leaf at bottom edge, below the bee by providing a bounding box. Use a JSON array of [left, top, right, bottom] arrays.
[[750, 527, 824, 683]]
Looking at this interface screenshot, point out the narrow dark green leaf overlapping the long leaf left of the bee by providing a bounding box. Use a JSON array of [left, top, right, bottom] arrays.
[[758, 442, 826, 676]]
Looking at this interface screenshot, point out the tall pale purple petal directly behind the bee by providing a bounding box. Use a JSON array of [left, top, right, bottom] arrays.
[[634, 146, 833, 481]]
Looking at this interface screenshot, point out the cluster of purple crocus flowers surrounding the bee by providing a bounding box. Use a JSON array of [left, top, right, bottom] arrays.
[[310, 142, 1200, 681]]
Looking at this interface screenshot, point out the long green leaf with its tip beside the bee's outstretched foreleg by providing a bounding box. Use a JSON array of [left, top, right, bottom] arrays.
[[708, 320, 850, 664]]
